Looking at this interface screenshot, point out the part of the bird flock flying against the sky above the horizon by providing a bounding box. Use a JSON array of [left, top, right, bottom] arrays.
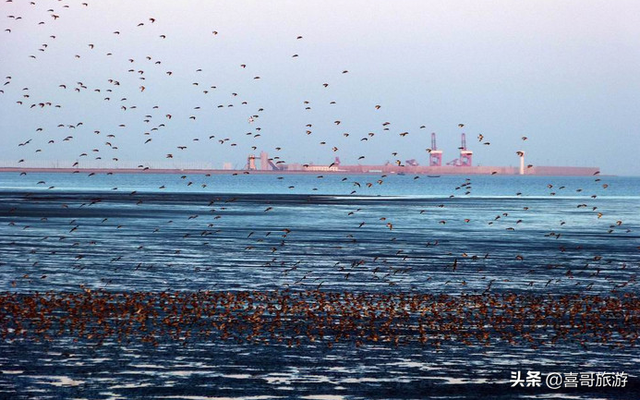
[[0, 1, 510, 175]]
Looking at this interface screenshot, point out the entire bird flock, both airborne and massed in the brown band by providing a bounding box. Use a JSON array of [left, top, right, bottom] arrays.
[[0, 0, 639, 350]]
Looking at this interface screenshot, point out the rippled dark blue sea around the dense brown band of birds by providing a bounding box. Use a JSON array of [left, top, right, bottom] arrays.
[[0, 173, 640, 399]]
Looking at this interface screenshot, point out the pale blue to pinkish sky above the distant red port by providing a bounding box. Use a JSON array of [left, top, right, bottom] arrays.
[[0, 0, 640, 175]]
